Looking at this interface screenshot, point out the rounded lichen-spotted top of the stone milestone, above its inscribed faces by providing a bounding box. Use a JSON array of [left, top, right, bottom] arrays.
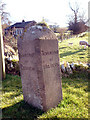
[[21, 25, 57, 40]]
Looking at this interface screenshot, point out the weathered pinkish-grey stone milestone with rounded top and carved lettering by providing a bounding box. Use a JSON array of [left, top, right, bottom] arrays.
[[18, 25, 62, 111]]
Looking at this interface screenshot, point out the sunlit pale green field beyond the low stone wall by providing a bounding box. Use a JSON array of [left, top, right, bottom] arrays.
[[59, 36, 89, 63]]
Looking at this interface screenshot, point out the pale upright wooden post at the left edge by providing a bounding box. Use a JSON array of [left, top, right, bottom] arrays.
[[0, 16, 5, 80]]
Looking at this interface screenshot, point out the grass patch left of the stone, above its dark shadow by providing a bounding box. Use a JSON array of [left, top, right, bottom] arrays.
[[2, 75, 23, 108]]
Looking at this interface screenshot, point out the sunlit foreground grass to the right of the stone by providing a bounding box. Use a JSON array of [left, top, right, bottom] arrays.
[[40, 78, 88, 119]]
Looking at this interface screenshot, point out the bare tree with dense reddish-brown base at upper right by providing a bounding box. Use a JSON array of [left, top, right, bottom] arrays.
[[68, 2, 87, 34]]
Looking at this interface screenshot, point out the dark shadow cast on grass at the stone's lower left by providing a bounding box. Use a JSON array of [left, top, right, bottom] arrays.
[[2, 100, 43, 120]]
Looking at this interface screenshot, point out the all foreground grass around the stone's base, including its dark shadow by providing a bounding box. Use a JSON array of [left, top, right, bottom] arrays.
[[1, 75, 88, 120]]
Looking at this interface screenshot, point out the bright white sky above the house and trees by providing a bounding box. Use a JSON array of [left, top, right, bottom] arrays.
[[3, 0, 89, 27]]
